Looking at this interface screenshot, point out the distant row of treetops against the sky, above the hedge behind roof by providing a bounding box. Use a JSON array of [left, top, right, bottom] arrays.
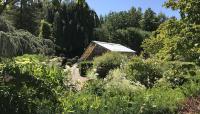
[[101, 7, 168, 32]]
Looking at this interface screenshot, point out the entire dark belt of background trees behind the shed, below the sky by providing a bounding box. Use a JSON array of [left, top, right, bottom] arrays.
[[0, 0, 168, 57]]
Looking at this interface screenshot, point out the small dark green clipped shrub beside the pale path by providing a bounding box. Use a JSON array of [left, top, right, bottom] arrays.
[[79, 61, 93, 76]]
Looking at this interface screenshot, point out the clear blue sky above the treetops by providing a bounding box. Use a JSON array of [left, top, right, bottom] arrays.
[[86, 0, 180, 18]]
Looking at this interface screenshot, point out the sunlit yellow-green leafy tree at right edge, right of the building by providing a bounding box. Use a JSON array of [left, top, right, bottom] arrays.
[[143, 20, 200, 62]]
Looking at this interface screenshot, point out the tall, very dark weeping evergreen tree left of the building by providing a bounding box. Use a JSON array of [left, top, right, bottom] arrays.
[[46, 0, 99, 56]]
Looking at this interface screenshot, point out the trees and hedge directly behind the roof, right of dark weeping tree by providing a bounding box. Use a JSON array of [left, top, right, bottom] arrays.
[[94, 7, 168, 54]]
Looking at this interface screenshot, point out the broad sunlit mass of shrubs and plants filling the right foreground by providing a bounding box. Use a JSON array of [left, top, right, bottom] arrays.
[[61, 54, 200, 114]]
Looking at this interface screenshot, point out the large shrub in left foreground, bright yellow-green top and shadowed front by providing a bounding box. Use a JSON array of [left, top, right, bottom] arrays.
[[0, 55, 67, 114]]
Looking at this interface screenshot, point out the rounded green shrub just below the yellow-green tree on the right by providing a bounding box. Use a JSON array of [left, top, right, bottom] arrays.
[[125, 57, 162, 88]]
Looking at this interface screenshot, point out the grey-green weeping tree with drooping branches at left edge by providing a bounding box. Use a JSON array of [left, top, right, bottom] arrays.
[[0, 30, 54, 57]]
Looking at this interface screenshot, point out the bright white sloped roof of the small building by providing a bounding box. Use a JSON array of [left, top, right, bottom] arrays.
[[93, 41, 135, 53]]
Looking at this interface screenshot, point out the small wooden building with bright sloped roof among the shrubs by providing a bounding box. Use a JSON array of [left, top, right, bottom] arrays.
[[80, 41, 136, 60]]
